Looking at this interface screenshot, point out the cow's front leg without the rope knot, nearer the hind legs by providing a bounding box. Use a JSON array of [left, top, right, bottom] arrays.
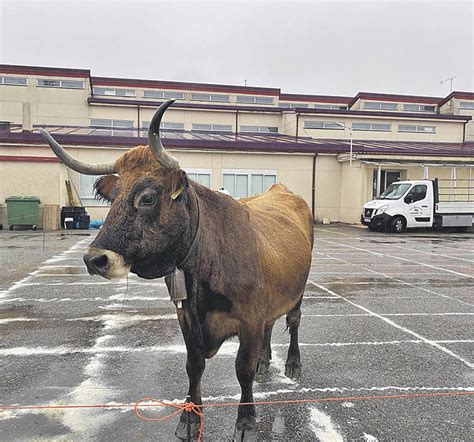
[[234, 327, 263, 442]]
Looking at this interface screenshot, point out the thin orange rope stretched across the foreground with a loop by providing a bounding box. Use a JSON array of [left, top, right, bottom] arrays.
[[0, 391, 474, 441]]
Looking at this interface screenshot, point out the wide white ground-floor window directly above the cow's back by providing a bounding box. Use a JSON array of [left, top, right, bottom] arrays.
[[222, 170, 276, 198]]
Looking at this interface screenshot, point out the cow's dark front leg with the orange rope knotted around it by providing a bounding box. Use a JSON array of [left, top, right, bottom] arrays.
[[175, 309, 206, 440]]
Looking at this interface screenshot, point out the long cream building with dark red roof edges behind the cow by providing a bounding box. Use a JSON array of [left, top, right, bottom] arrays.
[[0, 65, 474, 224]]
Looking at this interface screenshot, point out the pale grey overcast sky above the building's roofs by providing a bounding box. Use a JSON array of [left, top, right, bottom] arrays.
[[0, 0, 474, 96]]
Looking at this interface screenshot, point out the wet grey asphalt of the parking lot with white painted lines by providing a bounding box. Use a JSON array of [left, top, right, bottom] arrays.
[[0, 226, 474, 441]]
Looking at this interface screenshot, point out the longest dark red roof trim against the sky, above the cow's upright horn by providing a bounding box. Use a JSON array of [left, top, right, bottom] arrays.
[[92, 77, 280, 97]]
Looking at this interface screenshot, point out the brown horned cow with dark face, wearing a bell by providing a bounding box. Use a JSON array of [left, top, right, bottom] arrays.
[[41, 101, 313, 441]]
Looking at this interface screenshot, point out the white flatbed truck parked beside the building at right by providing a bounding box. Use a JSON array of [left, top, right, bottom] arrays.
[[361, 179, 474, 233]]
